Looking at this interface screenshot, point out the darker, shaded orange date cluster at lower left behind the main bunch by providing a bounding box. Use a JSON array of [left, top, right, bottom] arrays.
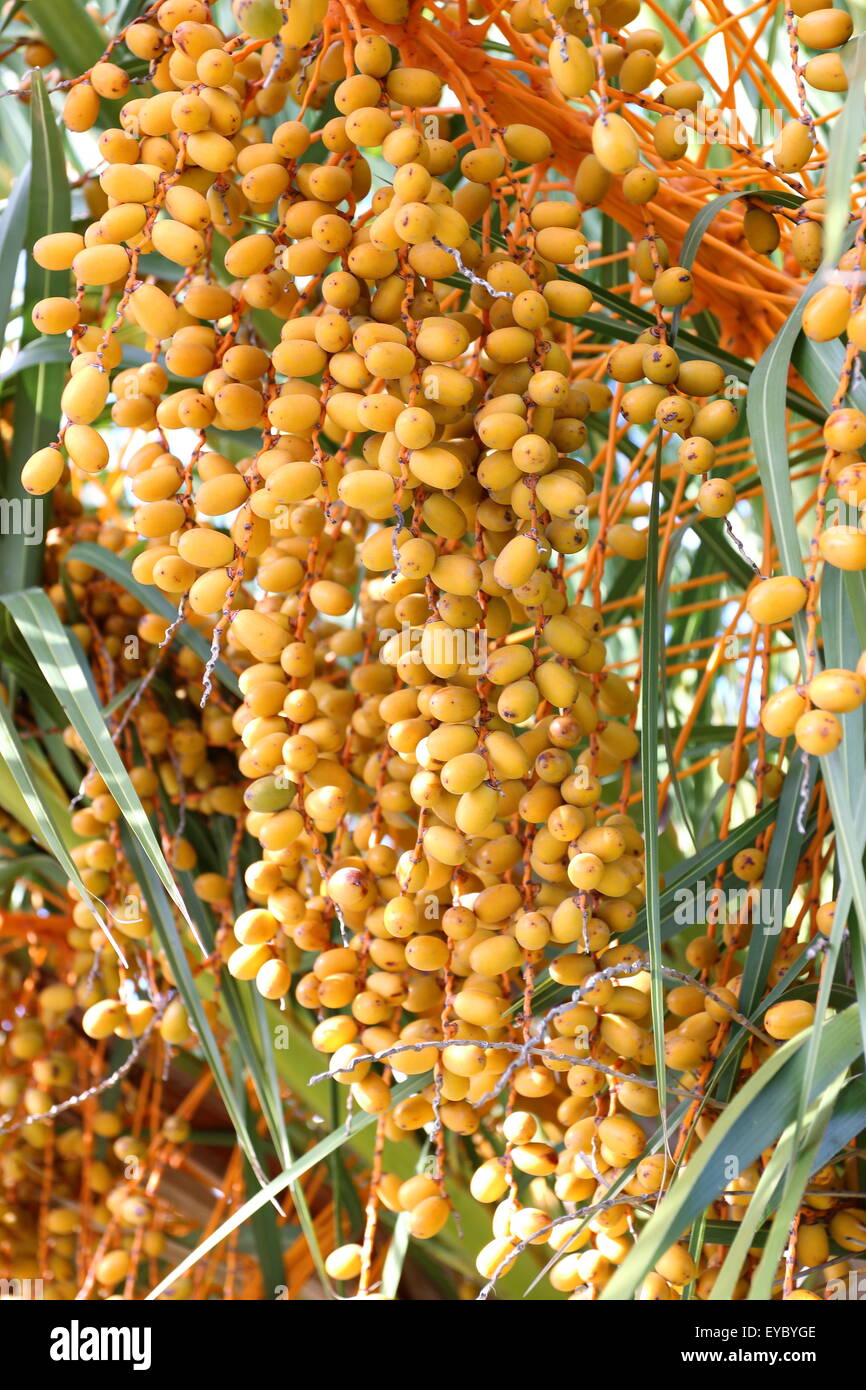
[[0, 517, 248, 1300]]
